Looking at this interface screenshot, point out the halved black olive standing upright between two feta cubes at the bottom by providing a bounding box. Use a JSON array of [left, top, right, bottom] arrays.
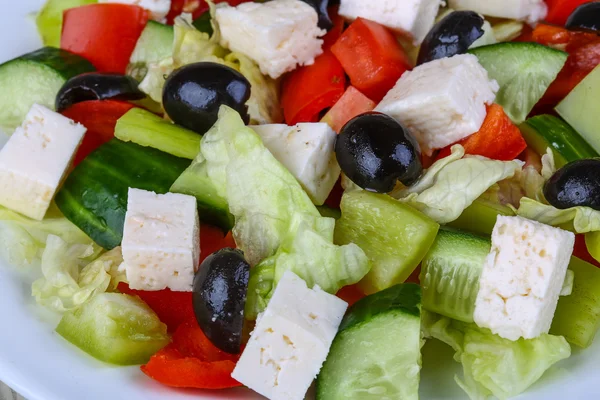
[[192, 248, 250, 354]]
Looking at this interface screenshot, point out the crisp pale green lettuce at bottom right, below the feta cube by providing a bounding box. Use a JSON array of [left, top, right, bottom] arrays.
[[421, 311, 571, 400]]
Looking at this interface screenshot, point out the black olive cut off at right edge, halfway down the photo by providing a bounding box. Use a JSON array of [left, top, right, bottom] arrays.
[[544, 159, 600, 210]]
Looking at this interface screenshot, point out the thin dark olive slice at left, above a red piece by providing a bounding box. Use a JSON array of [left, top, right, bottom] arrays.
[[55, 72, 146, 112]]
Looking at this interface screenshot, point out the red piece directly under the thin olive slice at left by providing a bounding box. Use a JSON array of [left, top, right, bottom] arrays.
[[61, 100, 135, 165]]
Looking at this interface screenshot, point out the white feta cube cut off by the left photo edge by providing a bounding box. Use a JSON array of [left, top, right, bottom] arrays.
[[0, 104, 86, 220]]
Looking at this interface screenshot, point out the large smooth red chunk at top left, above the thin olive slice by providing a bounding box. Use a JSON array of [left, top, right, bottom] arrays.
[[60, 3, 148, 74]]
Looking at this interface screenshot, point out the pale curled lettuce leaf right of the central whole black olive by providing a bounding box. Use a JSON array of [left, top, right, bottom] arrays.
[[392, 145, 522, 224]]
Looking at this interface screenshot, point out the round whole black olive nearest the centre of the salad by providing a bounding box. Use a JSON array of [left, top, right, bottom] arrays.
[[335, 112, 423, 193]]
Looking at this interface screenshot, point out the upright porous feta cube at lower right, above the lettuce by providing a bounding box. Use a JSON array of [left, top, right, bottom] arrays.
[[473, 216, 575, 340]]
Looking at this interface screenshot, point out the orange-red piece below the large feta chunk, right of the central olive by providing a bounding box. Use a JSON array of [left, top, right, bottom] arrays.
[[437, 104, 527, 161]]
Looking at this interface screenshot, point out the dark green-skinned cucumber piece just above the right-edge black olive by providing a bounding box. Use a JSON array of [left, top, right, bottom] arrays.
[[519, 115, 600, 168]]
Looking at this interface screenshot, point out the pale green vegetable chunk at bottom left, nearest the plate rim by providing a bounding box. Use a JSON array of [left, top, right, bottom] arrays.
[[56, 293, 169, 365]]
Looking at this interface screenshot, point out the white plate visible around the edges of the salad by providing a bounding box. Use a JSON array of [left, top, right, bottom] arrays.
[[0, 0, 600, 400]]
